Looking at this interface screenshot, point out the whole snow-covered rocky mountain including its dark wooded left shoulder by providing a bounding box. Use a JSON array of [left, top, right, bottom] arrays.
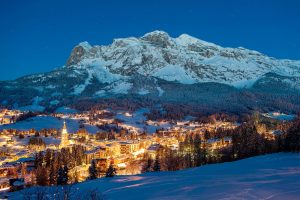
[[0, 31, 300, 112]]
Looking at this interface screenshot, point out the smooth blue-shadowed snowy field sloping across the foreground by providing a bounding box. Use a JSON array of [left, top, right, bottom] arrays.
[[9, 153, 300, 200]]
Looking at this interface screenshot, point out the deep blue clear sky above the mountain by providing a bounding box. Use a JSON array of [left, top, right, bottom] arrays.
[[0, 0, 300, 80]]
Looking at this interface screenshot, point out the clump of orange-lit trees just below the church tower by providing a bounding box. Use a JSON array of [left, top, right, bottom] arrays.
[[35, 145, 85, 186]]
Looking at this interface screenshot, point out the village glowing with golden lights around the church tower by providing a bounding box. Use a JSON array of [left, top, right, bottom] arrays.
[[0, 110, 284, 191]]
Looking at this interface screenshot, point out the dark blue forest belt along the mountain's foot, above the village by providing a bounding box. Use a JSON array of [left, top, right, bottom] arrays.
[[71, 89, 300, 121]]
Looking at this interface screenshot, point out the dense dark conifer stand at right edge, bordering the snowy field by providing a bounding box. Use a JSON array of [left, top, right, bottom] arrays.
[[232, 116, 300, 155]]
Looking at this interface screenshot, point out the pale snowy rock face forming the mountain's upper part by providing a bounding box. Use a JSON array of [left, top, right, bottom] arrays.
[[59, 31, 300, 93]]
